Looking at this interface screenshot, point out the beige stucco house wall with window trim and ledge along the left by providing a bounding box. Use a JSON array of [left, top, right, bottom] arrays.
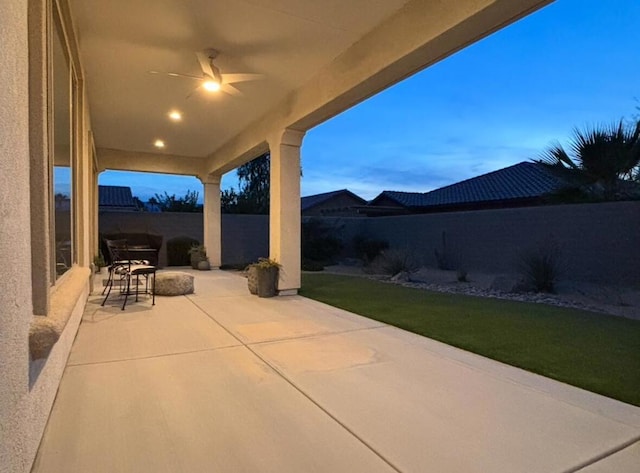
[[0, 0, 94, 473]]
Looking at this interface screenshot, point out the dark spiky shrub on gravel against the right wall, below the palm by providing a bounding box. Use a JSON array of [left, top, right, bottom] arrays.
[[517, 240, 561, 292]]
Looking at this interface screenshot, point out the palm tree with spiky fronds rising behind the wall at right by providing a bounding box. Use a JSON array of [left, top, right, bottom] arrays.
[[538, 120, 640, 200]]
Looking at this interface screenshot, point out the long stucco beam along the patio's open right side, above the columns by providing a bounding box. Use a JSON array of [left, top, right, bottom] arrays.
[[206, 0, 553, 174]]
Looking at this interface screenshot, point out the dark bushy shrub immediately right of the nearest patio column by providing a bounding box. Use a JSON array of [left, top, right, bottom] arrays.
[[301, 218, 343, 264]]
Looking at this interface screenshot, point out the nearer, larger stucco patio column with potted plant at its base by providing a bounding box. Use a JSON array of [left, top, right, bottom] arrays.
[[268, 129, 304, 295]]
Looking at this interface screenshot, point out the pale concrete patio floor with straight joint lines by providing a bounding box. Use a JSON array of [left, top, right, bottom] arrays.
[[33, 271, 640, 473]]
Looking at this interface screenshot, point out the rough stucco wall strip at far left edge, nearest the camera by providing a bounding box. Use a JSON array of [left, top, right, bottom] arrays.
[[0, 0, 32, 473]]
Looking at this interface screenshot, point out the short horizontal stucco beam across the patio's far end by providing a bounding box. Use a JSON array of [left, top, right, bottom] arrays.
[[96, 148, 205, 176]]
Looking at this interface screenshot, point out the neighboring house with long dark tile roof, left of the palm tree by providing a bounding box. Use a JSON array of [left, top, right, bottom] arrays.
[[361, 162, 577, 216]]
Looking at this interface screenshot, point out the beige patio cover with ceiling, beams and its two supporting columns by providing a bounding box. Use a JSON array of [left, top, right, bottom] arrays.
[[71, 0, 550, 291]]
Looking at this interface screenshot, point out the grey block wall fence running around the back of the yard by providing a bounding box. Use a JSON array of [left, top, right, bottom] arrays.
[[100, 202, 640, 286]]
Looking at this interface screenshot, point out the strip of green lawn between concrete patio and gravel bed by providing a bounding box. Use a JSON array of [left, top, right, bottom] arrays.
[[300, 273, 640, 406]]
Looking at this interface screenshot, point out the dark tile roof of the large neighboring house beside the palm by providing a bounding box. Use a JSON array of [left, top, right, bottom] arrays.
[[373, 162, 572, 207]]
